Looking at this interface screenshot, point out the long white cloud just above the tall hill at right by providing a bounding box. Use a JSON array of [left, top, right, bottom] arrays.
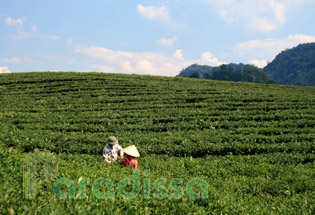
[[230, 34, 315, 61]]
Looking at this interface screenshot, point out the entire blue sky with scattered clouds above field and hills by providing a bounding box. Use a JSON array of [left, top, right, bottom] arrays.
[[0, 0, 315, 76]]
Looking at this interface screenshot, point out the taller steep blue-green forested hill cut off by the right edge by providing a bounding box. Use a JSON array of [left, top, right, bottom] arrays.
[[263, 43, 315, 86]]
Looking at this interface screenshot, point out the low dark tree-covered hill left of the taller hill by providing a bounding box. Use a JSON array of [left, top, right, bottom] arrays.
[[177, 63, 274, 84]]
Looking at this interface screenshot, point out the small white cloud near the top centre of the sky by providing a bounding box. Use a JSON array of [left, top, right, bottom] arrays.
[[137, 4, 183, 29]]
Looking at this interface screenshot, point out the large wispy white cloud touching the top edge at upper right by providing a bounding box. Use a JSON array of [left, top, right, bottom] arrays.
[[202, 0, 309, 32]]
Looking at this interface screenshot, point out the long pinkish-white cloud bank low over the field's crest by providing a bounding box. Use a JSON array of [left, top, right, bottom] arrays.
[[75, 47, 225, 76]]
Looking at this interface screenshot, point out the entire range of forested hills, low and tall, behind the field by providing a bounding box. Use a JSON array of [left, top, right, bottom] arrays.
[[177, 43, 315, 86]]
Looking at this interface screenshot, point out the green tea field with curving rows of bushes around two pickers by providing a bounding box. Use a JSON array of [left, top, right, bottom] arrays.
[[0, 72, 315, 214]]
